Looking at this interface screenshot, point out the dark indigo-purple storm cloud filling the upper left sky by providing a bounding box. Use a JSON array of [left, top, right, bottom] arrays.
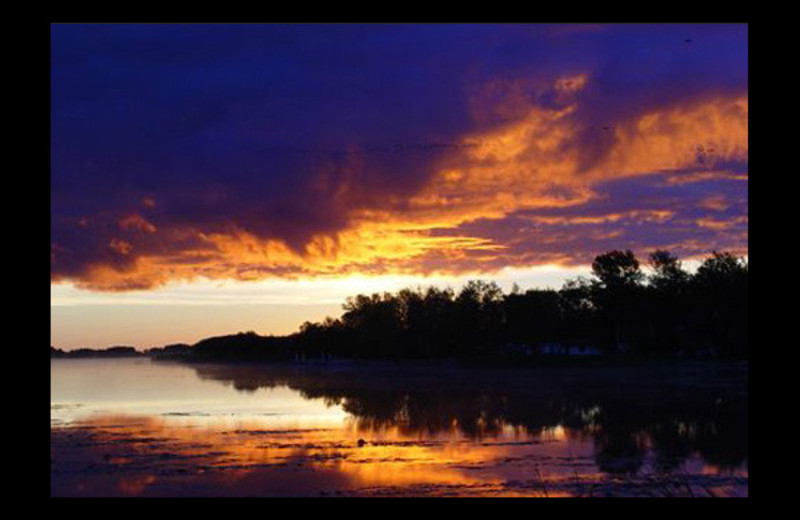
[[51, 25, 747, 289]]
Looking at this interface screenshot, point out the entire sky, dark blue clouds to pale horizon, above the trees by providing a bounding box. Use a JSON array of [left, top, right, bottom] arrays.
[[50, 24, 748, 348]]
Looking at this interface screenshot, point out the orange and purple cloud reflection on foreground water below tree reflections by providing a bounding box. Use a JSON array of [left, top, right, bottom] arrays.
[[51, 416, 746, 497]]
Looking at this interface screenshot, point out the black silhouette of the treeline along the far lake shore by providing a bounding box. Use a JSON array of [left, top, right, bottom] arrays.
[[51, 250, 748, 361]]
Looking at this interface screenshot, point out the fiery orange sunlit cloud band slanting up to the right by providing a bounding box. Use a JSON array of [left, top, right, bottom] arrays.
[[56, 74, 748, 290]]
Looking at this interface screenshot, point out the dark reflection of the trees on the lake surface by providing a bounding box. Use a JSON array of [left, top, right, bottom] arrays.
[[189, 365, 747, 474]]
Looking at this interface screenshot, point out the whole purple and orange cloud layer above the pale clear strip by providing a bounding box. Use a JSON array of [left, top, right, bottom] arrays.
[[51, 26, 748, 291]]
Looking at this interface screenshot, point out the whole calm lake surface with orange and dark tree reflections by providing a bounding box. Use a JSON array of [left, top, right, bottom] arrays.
[[51, 358, 748, 496]]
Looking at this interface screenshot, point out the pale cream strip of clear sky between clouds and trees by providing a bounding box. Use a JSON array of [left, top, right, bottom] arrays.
[[50, 259, 716, 350]]
